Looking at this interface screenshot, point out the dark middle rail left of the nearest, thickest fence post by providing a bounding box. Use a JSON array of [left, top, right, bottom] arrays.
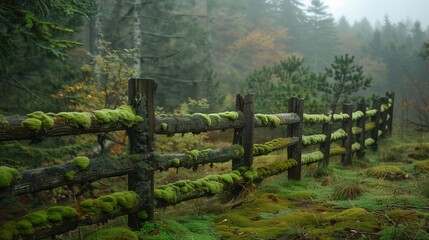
[[0, 155, 144, 198]]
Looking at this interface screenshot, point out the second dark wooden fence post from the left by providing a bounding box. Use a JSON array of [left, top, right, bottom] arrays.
[[232, 94, 255, 170]]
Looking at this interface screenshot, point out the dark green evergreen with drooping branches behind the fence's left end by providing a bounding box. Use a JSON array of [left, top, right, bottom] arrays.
[[0, 0, 94, 113]]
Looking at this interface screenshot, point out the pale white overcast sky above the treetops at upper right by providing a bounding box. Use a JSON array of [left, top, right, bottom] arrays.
[[303, 0, 429, 29]]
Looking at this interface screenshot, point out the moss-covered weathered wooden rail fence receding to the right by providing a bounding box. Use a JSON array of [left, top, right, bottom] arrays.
[[0, 79, 394, 239]]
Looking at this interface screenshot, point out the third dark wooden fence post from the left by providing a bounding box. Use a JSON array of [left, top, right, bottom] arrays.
[[287, 97, 304, 180]]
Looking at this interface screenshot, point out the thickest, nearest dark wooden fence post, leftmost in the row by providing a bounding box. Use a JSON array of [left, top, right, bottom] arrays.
[[127, 78, 158, 230]]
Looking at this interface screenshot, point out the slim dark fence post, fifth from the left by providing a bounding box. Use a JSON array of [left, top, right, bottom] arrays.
[[341, 104, 353, 166]]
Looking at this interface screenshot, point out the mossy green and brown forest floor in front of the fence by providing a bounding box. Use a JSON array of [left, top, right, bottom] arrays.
[[136, 131, 429, 240]]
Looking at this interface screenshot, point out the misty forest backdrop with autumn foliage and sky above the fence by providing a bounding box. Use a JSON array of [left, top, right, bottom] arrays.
[[0, 0, 429, 123]]
